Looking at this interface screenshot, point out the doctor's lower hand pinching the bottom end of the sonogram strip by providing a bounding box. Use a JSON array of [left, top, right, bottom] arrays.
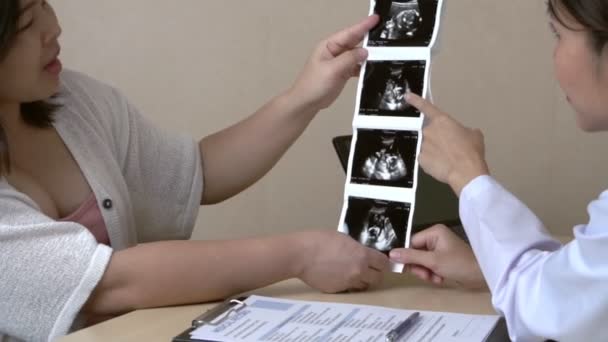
[[390, 225, 487, 289]]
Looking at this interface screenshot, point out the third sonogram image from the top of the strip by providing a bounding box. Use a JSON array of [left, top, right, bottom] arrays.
[[351, 129, 418, 188]]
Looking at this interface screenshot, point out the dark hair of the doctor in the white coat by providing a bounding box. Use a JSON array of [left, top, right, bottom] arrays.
[[547, 0, 608, 55]]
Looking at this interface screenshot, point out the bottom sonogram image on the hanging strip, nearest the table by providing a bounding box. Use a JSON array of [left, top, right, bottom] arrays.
[[344, 197, 410, 253]]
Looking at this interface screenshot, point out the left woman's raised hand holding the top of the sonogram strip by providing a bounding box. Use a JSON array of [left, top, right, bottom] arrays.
[[288, 15, 379, 112]]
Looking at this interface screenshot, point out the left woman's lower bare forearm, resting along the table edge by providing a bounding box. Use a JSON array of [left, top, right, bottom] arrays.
[[84, 234, 308, 315]]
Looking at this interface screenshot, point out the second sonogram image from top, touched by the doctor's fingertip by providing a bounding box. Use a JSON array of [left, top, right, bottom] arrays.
[[359, 61, 426, 117]]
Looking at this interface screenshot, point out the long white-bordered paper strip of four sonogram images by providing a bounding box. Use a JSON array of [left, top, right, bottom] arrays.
[[338, 0, 443, 272]]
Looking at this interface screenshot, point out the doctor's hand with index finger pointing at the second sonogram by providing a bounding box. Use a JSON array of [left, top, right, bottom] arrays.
[[407, 93, 490, 196]]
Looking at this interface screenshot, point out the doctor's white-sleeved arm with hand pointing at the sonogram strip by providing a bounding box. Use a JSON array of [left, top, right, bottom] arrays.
[[390, 92, 608, 341]]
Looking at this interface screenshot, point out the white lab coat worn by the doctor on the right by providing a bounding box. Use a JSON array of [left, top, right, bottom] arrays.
[[460, 176, 608, 341]]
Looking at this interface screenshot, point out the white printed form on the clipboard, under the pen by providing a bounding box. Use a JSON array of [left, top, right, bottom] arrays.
[[191, 296, 499, 342]]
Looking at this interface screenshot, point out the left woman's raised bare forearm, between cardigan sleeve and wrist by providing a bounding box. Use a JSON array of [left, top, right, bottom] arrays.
[[199, 91, 317, 204]]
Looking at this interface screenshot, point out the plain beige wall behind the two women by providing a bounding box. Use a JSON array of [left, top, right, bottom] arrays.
[[52, 0, 608, 238]]
